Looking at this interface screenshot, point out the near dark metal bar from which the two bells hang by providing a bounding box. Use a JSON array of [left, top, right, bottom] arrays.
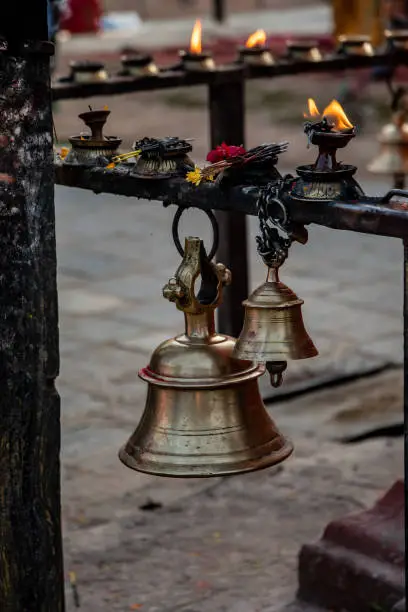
[[55, 164, 408, 238]]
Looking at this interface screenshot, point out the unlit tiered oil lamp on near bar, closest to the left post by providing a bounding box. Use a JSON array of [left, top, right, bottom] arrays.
[[64, 109, 122, 166]]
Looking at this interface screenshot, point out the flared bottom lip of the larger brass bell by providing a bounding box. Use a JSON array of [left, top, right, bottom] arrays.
[[119, 434, 293, 478]]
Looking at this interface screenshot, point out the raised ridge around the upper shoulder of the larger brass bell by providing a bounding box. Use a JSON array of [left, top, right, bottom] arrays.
[[138, 364, 265, 389]]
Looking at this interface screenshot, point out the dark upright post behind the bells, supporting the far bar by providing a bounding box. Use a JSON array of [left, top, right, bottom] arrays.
[[209, 70, 249, 337]]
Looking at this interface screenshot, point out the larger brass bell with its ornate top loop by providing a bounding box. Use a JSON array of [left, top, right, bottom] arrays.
[[119, 238, 293, 477]]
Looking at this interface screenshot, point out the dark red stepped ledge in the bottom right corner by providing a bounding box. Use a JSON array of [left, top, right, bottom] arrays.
[[298, 481, 405, 612]]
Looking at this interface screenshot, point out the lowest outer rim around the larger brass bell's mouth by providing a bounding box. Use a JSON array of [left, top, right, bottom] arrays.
[[118, 435, 294, 478]]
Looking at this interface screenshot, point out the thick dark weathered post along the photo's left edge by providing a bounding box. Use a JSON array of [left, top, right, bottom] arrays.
[[0, 0, 64, 612]]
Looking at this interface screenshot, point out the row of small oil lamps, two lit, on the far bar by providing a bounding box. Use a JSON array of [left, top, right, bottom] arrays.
[[63, 20, 408, 83]]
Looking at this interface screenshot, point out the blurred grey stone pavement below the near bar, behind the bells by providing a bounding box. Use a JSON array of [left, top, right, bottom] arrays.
[[56, 173, 403, 612]]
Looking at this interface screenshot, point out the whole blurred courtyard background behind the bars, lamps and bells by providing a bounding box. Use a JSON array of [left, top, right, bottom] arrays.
[[50, 0, 407, 612]]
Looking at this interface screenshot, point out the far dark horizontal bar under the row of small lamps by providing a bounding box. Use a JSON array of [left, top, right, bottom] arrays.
[[52, 50, 408, 100]]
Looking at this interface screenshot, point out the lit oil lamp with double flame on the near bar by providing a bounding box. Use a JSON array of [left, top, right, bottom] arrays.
[[291, 98, 363, 201]]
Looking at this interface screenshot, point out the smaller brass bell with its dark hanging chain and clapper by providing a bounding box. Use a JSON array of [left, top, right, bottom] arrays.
[[234, 179, 318, 380]]
